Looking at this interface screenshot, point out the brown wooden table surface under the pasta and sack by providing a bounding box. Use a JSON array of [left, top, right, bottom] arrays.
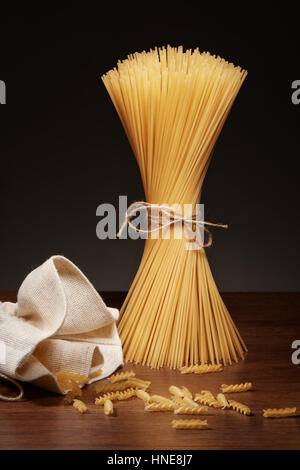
[[0, 292, 300, 450]]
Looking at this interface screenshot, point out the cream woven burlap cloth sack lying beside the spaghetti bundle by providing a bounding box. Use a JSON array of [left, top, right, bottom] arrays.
[[0, 256, 123, 393]]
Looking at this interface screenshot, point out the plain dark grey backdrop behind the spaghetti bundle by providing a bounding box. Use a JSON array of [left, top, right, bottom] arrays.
[[0, 2, 300, 291]]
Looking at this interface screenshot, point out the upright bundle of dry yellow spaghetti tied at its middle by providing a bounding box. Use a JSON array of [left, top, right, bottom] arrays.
[[102, 46, 247, 368]]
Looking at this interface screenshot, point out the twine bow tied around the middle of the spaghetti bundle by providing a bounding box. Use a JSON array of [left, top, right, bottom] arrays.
[[117, 201, 228, 250]]
